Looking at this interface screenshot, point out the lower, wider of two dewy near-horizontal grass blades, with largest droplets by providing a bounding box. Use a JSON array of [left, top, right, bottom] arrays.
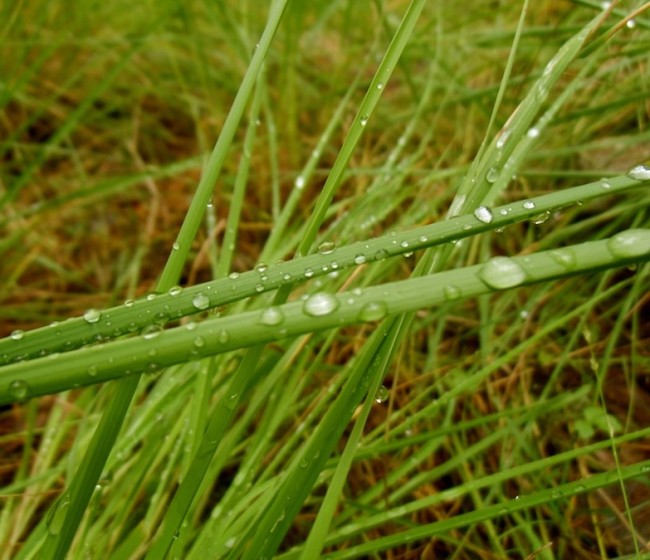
[[0, 229, 650, 403]]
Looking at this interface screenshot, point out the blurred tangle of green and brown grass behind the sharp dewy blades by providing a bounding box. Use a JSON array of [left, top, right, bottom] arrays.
[[0, 0, 650, 558]]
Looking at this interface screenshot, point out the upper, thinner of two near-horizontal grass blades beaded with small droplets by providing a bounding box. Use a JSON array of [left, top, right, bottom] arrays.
[[0, 176, 645, 363]]
